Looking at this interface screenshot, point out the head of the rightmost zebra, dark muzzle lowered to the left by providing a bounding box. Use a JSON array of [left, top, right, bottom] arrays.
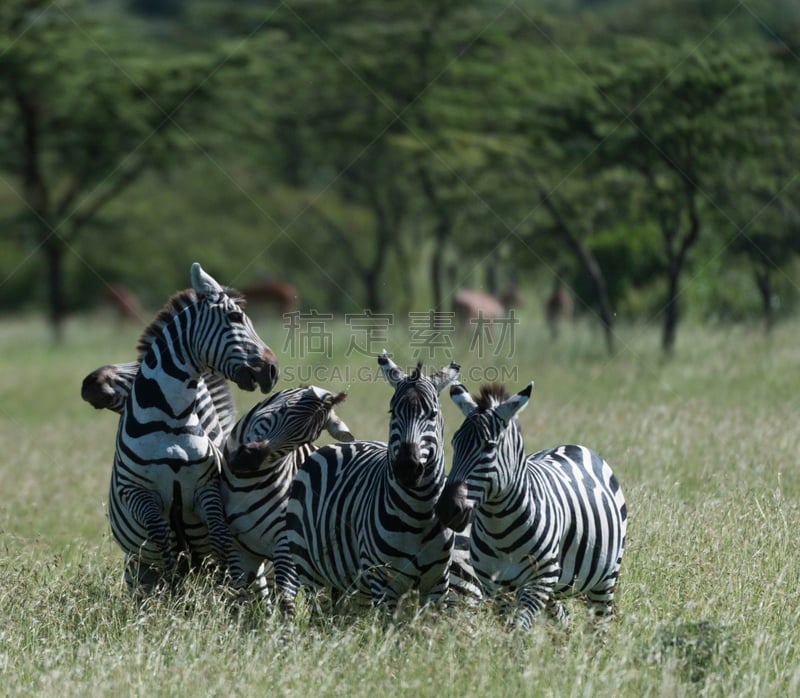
[[436, 381, 533, 531]]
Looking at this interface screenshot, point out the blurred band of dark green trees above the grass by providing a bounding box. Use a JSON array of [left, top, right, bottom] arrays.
[[0, 0, 800, 342]]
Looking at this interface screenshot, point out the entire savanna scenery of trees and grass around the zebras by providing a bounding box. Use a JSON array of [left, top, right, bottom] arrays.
[[0, 0, 800, 696]]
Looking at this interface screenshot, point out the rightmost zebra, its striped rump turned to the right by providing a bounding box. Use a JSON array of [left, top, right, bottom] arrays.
[[436, 382, 627, 630]]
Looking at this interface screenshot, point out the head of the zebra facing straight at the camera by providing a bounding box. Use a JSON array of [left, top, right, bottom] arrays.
[[378, 350, 461, 488]]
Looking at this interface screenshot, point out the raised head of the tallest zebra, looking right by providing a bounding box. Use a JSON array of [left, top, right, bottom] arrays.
[[187, 262, 278, 393]]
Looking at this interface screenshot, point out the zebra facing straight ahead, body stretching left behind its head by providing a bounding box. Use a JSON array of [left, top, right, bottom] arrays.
[[275, 350, 460, 614]]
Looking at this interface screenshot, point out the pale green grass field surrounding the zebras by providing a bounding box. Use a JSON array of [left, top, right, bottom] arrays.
[[0, 318, 800, 698]]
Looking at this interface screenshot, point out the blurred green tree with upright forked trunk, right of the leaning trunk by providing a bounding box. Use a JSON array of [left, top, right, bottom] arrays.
[[586, 40, 792, 352]]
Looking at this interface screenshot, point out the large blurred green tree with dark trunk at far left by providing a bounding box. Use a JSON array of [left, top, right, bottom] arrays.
[[0, 0, 219, 338]]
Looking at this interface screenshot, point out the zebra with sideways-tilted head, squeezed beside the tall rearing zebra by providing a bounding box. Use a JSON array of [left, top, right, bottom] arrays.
[[220, 385, 354, 602]]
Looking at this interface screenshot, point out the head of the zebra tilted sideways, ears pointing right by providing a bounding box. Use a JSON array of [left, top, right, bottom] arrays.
[[225, 385, 355, 473]]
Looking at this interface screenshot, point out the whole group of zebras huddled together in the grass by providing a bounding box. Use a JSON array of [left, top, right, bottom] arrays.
[[81, 263, 627, 630]]
